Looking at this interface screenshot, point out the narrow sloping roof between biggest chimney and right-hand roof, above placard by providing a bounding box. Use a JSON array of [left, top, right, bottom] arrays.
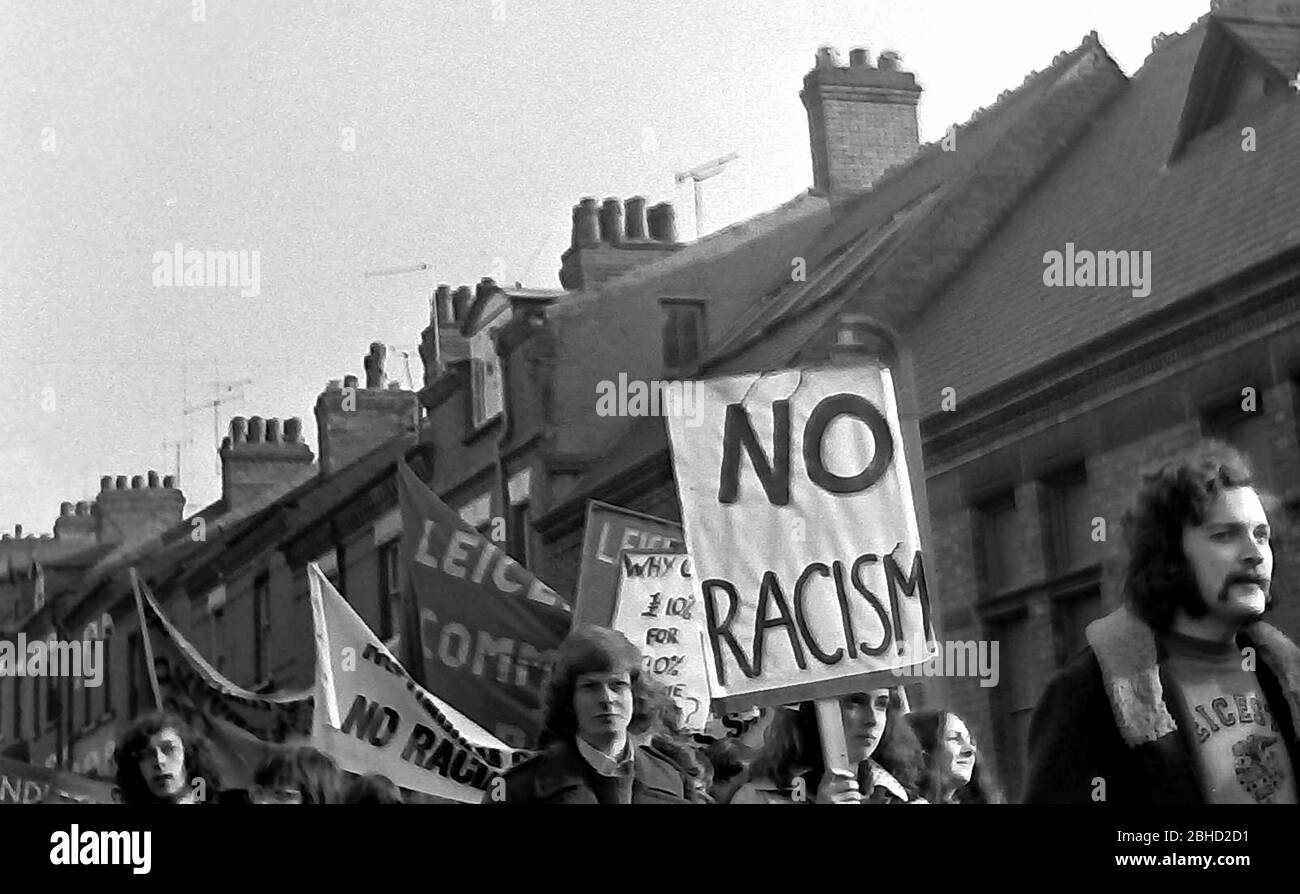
[[543, 34, 1123, 511]]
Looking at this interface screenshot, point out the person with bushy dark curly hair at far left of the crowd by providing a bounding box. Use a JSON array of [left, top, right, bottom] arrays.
[[114, 711, 221, 804]]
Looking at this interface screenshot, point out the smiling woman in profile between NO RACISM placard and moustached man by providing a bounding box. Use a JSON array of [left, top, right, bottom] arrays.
[[907, 709, 1006, 804]]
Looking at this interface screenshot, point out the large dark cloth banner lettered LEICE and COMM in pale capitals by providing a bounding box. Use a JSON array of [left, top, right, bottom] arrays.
[[398, 463, 572, 747]]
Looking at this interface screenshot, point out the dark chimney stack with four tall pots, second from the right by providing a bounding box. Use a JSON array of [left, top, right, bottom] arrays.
[[560, 196, 681, 291]]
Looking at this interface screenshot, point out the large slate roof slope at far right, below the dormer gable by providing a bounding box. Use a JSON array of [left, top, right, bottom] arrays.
[[909, 13, 1300, 412]]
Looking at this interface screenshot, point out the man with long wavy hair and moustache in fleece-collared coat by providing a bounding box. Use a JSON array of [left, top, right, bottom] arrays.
[[1024, 441, 1300, 804]]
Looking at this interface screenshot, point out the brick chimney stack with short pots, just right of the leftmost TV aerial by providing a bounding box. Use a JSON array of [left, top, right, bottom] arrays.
[[220, 416, 316, 511]]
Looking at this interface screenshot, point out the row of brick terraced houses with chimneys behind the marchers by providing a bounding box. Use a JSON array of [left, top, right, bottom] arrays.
[[0, 3, 1300, 794]]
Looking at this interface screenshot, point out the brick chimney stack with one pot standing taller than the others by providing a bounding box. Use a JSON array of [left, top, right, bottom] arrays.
[[316, 345, 416, 474]]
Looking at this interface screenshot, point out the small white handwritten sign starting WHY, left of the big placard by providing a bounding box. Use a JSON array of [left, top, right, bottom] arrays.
[[614, 550, 709, 730]]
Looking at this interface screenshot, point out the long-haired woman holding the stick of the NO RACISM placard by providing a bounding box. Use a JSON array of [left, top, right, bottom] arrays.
[[728, 689, 926, 804]]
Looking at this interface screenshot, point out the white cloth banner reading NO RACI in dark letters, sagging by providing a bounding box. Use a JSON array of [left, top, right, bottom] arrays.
[[307, 563, 528, 803]]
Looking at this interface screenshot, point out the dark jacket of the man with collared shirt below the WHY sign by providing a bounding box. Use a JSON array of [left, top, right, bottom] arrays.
[[484, 739, 696, 804]]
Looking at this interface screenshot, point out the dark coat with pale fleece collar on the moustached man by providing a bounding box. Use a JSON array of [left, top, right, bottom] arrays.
[[1024, 607, 1300, 804]]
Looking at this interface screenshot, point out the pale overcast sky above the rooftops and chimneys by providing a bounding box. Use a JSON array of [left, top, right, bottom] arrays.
[[0, 0, 1209, 533]]
